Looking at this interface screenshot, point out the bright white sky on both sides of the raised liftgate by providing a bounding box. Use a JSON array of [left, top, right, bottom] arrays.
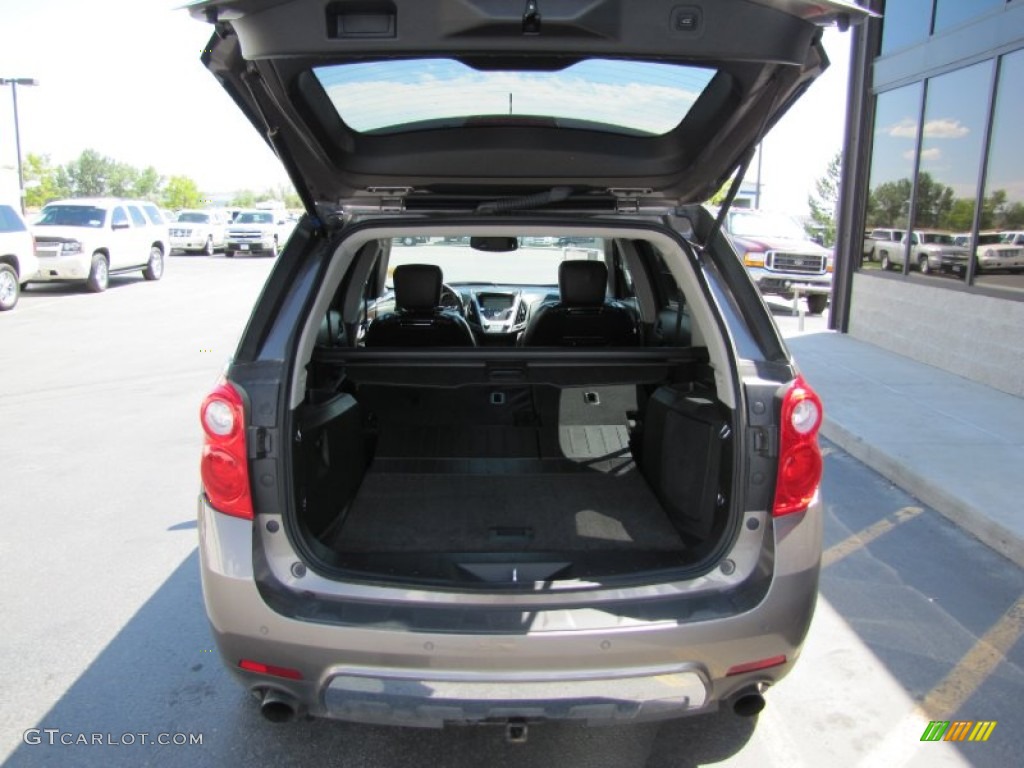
[[0, 0, 849, 214]]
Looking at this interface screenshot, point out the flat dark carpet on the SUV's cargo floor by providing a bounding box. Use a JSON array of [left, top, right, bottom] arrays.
[[331, 467, 684, 553]]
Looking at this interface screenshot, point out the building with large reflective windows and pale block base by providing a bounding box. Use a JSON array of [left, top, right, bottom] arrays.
[[830, 0, 1024, 396]]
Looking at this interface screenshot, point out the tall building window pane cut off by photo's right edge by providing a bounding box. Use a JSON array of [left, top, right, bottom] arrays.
[[974, 50, 1024, 292]]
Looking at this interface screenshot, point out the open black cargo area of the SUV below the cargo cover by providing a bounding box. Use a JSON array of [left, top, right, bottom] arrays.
[[294, 360, 731, 586]]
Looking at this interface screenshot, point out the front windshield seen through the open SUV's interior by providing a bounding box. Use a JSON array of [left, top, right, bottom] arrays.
[[387, 237, 604, 289]]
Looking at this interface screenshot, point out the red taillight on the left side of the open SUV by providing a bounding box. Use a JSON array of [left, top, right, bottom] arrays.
[[200, 382, 253, 520]]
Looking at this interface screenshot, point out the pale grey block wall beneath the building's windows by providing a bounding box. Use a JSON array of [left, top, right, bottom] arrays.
[[849, 272, 1024, 397]]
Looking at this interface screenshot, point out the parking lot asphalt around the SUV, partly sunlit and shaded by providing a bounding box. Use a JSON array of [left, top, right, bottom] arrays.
[[0, 249, 1024, 768]]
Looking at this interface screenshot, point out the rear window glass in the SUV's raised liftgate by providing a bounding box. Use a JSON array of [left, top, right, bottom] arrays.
[[313, 58, 715, 135]]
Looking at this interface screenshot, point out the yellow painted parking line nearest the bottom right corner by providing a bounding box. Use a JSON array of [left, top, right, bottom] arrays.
[[921, 595, 1024, 720]]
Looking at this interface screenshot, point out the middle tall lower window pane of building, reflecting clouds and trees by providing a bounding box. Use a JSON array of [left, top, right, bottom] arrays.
[[909, 61, 994, 279]]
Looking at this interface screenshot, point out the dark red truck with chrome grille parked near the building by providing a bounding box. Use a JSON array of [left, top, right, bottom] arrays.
[[725, 208, 834, 314]]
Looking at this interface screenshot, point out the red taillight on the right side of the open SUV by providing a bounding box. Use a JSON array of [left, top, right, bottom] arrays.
[[772, 376, 822, 517]]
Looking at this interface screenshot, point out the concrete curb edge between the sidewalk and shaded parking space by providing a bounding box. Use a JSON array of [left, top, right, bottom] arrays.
[[821, 416, 1024, 568]]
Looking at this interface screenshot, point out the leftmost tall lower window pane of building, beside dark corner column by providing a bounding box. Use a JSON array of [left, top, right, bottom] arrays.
[[863, 83, 924, 269]]
